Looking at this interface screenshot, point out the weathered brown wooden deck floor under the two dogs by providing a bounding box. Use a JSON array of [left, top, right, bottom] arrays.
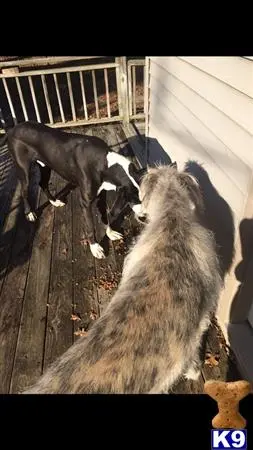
[[0, 124, 241, 393]]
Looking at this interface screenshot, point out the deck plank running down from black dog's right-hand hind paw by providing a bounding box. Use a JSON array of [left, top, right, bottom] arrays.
[[10, 188, 54, 393]]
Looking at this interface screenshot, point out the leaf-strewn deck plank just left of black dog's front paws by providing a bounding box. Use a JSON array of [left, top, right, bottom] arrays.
[[72, 128, 99, 340]]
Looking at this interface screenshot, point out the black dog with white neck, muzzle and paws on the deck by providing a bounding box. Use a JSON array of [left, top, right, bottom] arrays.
[[0, 121, 145, 258]]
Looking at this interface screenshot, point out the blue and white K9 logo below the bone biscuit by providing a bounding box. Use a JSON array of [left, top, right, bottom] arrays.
[[211, 430, 247, 450]]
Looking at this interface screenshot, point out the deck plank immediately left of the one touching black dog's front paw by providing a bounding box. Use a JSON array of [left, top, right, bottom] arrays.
[[43, 172, 73, 371]]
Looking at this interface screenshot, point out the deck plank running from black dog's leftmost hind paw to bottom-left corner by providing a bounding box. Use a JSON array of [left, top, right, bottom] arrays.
[[0, 164, 38, 393]]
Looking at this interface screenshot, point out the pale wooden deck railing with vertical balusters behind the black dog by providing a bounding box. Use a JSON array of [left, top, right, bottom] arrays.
[[0, 57, 145, 128]]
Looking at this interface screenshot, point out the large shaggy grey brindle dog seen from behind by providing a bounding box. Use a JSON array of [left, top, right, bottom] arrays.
[[23, 166, 222, 394]]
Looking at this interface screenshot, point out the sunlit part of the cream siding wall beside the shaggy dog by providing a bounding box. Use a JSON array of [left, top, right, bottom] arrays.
[[148, 57, 253, 342]]
